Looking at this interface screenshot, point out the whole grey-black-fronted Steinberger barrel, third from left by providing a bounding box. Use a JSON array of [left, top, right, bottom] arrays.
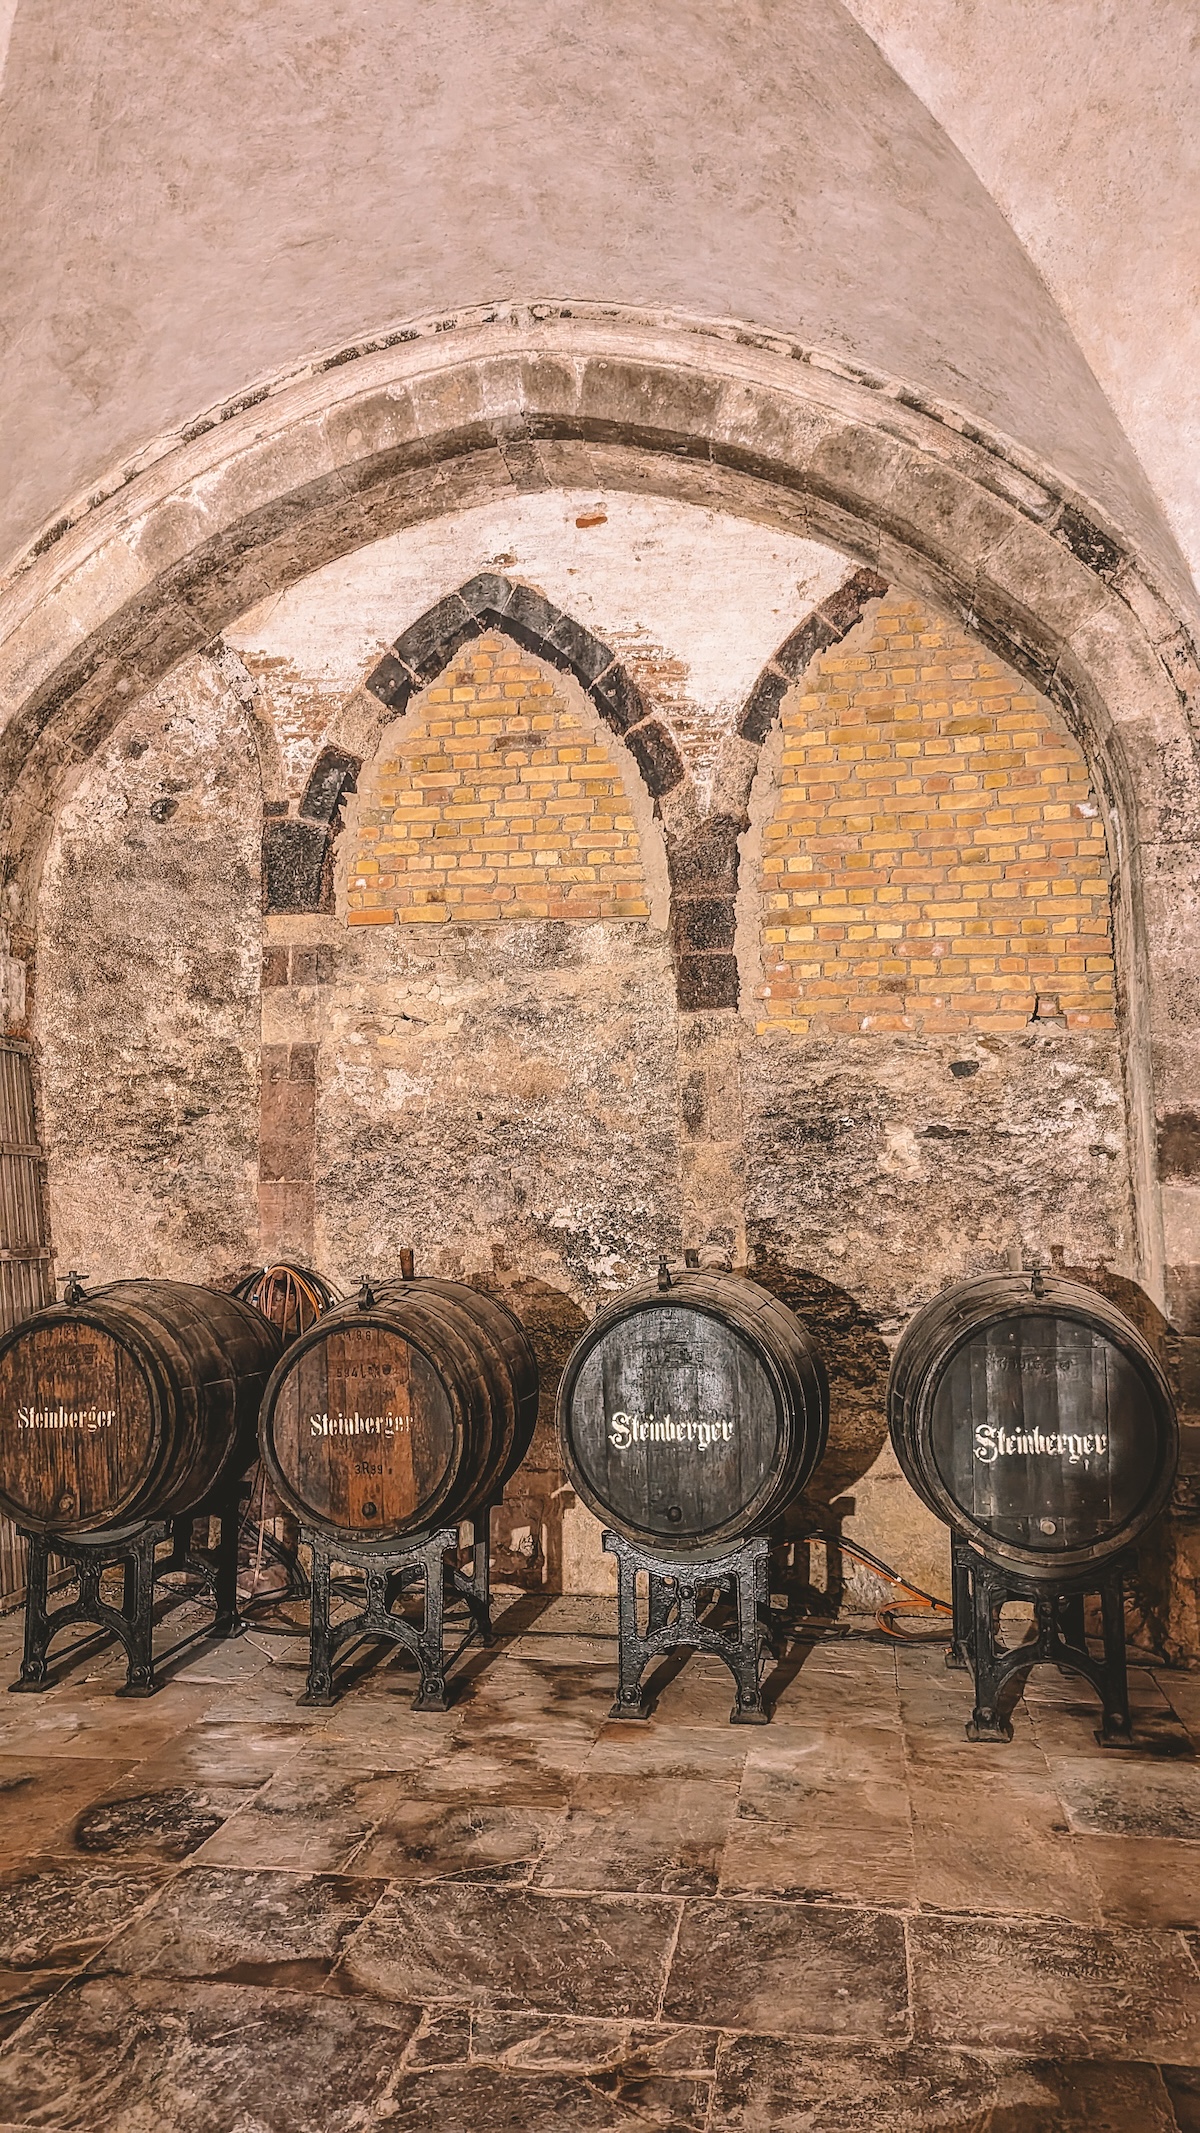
[[558, 1269, 829, 1555]]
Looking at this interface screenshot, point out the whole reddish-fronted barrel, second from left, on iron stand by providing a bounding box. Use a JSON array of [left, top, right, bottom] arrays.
[[260, 1278, 537, 1542]]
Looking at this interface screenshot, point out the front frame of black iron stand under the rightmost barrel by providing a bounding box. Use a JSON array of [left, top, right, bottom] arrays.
[[966, 1546, 1132, 1747]]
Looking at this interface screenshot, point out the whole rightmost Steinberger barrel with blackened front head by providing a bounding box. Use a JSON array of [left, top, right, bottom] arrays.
[[889, 1273, 1179, 1581]]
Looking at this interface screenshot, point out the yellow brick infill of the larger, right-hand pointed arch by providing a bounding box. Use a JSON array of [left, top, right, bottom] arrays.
[[757, 595, 1115, 1035]]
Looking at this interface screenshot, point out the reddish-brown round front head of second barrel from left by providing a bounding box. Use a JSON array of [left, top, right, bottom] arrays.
[[264, 1318, 460, 1540]]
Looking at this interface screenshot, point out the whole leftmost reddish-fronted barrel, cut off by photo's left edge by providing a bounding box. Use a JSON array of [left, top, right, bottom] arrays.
[[0, 1282, 279, 1534]]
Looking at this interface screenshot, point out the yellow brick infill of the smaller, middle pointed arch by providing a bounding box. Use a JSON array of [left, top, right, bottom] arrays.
[[347, 631, 650, 926]]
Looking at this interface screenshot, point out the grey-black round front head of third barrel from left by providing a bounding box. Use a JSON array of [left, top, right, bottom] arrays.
[[563, 1303, 782, 1549]]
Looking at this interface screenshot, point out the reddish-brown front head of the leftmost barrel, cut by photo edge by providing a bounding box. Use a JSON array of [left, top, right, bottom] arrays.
[[0, 1318, 153, 1531]]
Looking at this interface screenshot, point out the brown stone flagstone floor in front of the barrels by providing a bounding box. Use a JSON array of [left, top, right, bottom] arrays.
[[0, 1598, 1200, 2133]]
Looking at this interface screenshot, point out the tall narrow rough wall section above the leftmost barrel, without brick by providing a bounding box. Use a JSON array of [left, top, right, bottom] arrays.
[[32, 659, 262, 1282]]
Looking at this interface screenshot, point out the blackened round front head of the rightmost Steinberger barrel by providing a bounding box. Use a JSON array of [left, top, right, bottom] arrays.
[[929, 1312, 1162, 1557]]
